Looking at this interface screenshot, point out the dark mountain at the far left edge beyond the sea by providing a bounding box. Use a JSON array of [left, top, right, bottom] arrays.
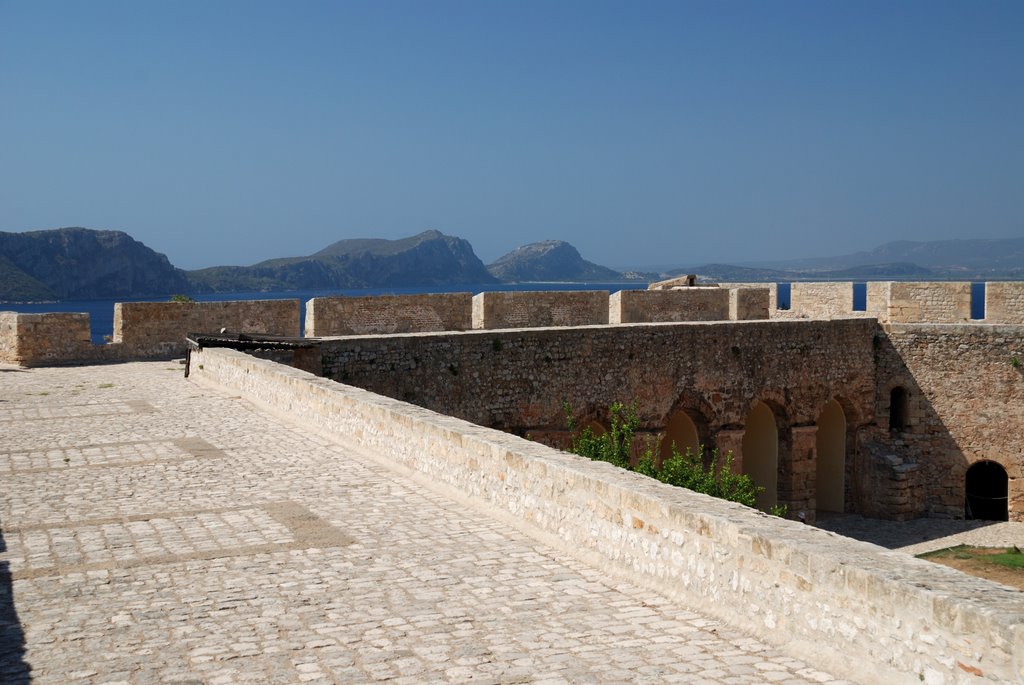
[[0, 227, 188, 302]]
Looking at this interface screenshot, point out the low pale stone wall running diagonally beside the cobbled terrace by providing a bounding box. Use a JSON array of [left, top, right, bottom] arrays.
[[191, 348, 1024, 685]]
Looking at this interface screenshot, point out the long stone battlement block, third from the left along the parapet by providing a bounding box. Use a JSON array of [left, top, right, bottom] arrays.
[[305, 293, 473, 338]]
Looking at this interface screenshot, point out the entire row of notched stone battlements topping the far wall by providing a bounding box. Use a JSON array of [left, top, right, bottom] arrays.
[[0, 280, 1024, 366]]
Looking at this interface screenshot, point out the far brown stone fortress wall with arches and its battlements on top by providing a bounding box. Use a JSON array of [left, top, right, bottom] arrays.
[[0, 283, 1024, 520]]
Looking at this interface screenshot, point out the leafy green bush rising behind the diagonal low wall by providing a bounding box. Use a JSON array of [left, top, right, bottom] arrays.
[[562, 401, 774, 513]]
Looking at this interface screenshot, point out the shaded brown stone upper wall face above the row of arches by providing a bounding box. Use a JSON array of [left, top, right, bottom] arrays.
[[321, 319, 877, 434]]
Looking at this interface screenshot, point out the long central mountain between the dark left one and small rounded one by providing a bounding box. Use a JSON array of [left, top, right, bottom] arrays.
[[188, 230, 495, 292]]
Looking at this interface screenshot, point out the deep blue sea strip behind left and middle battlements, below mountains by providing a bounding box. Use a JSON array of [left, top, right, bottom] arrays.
[[0, 283, 647, 345]]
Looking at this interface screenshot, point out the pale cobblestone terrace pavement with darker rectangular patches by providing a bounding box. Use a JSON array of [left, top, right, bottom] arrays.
[[0, 362, 849, 685]]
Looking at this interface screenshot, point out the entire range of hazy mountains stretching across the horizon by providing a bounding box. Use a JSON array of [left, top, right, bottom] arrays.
[[0, 227, 1024, 302]]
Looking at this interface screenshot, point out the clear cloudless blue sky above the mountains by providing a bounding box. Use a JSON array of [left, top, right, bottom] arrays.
[[0, 0, 1024, 268]]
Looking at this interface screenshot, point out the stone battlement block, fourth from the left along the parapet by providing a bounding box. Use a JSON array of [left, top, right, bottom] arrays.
[[473, 290, 608, 330]]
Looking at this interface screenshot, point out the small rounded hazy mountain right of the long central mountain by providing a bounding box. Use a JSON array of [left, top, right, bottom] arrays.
[[487, 241, 626, 283]]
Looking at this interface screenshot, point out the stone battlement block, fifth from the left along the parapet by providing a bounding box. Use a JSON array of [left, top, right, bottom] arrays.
[[608, 286, 729, 324]]
